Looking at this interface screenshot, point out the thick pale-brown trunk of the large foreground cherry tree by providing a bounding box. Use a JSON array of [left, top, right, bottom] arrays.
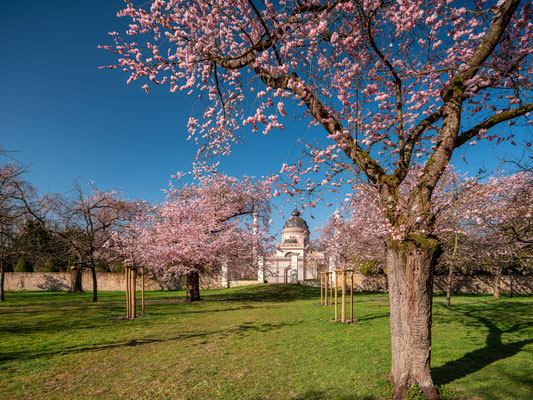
[[387, 235, 439, 400]]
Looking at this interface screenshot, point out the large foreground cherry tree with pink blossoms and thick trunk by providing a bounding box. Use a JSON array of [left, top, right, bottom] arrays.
[[105, 0, 533, 399]]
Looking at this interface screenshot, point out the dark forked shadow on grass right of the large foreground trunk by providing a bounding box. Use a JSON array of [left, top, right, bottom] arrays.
[[431, 304, 533, 385]]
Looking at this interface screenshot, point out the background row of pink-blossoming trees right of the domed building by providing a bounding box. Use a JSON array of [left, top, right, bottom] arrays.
[[320, 169, 533, 306]]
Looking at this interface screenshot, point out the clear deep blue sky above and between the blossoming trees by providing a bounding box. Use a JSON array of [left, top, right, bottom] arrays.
[[0, 0, 528, 238]]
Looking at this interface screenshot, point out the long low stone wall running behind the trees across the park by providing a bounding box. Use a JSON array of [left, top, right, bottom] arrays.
[[5, 272, 533, 294]]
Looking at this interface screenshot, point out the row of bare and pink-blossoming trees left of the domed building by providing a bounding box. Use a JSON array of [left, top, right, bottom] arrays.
[[0, 148, 270, 302]]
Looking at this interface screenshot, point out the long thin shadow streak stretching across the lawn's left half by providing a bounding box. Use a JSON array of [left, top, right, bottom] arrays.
[[0, 321, 301, 366]]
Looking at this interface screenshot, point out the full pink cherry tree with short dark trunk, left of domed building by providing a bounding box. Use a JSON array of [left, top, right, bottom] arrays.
[[132, 174, 270, 302]]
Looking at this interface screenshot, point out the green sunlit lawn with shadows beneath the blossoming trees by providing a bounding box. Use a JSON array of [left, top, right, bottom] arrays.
[[0, 285, 533, 400]]
